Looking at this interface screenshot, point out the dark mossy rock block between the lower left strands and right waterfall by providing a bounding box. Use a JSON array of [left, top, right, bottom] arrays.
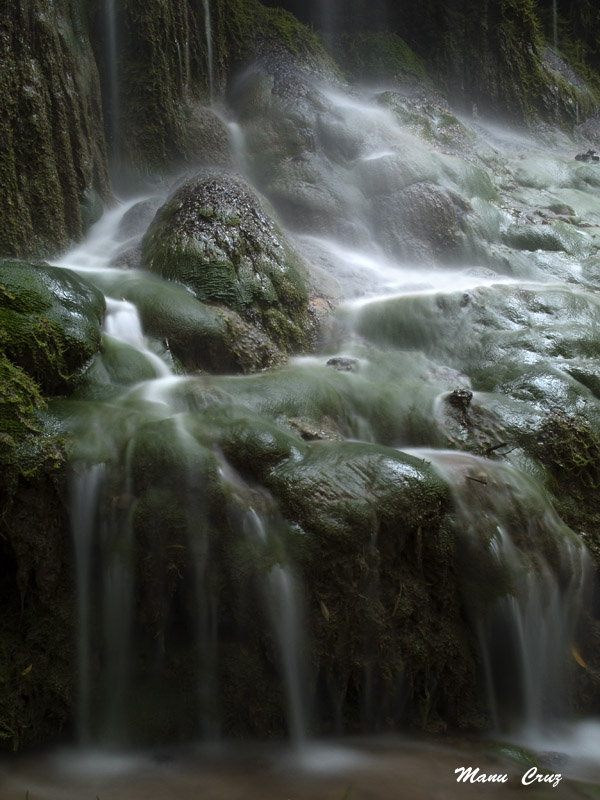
[[258, 441, 477, 729]]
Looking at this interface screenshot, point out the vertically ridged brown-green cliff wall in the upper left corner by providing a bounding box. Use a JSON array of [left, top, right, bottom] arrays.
[[0, 0, 109, 257]]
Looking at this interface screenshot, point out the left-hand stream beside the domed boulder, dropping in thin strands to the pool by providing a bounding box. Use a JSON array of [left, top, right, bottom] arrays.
[[52, 199, 310, 745]]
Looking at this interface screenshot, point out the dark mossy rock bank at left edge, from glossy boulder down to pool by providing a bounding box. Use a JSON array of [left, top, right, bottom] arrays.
[[0, 261, 104, 748]]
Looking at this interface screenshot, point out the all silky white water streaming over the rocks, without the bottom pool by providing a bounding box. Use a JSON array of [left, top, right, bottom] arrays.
[[43, 67, 600, 788]]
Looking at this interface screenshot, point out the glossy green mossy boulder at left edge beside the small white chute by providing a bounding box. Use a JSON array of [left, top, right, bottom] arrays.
[[0, 261, 104, 394]]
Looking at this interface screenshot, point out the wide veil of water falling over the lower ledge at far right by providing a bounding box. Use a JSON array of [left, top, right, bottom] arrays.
[[422, 451, 590, 737]]
